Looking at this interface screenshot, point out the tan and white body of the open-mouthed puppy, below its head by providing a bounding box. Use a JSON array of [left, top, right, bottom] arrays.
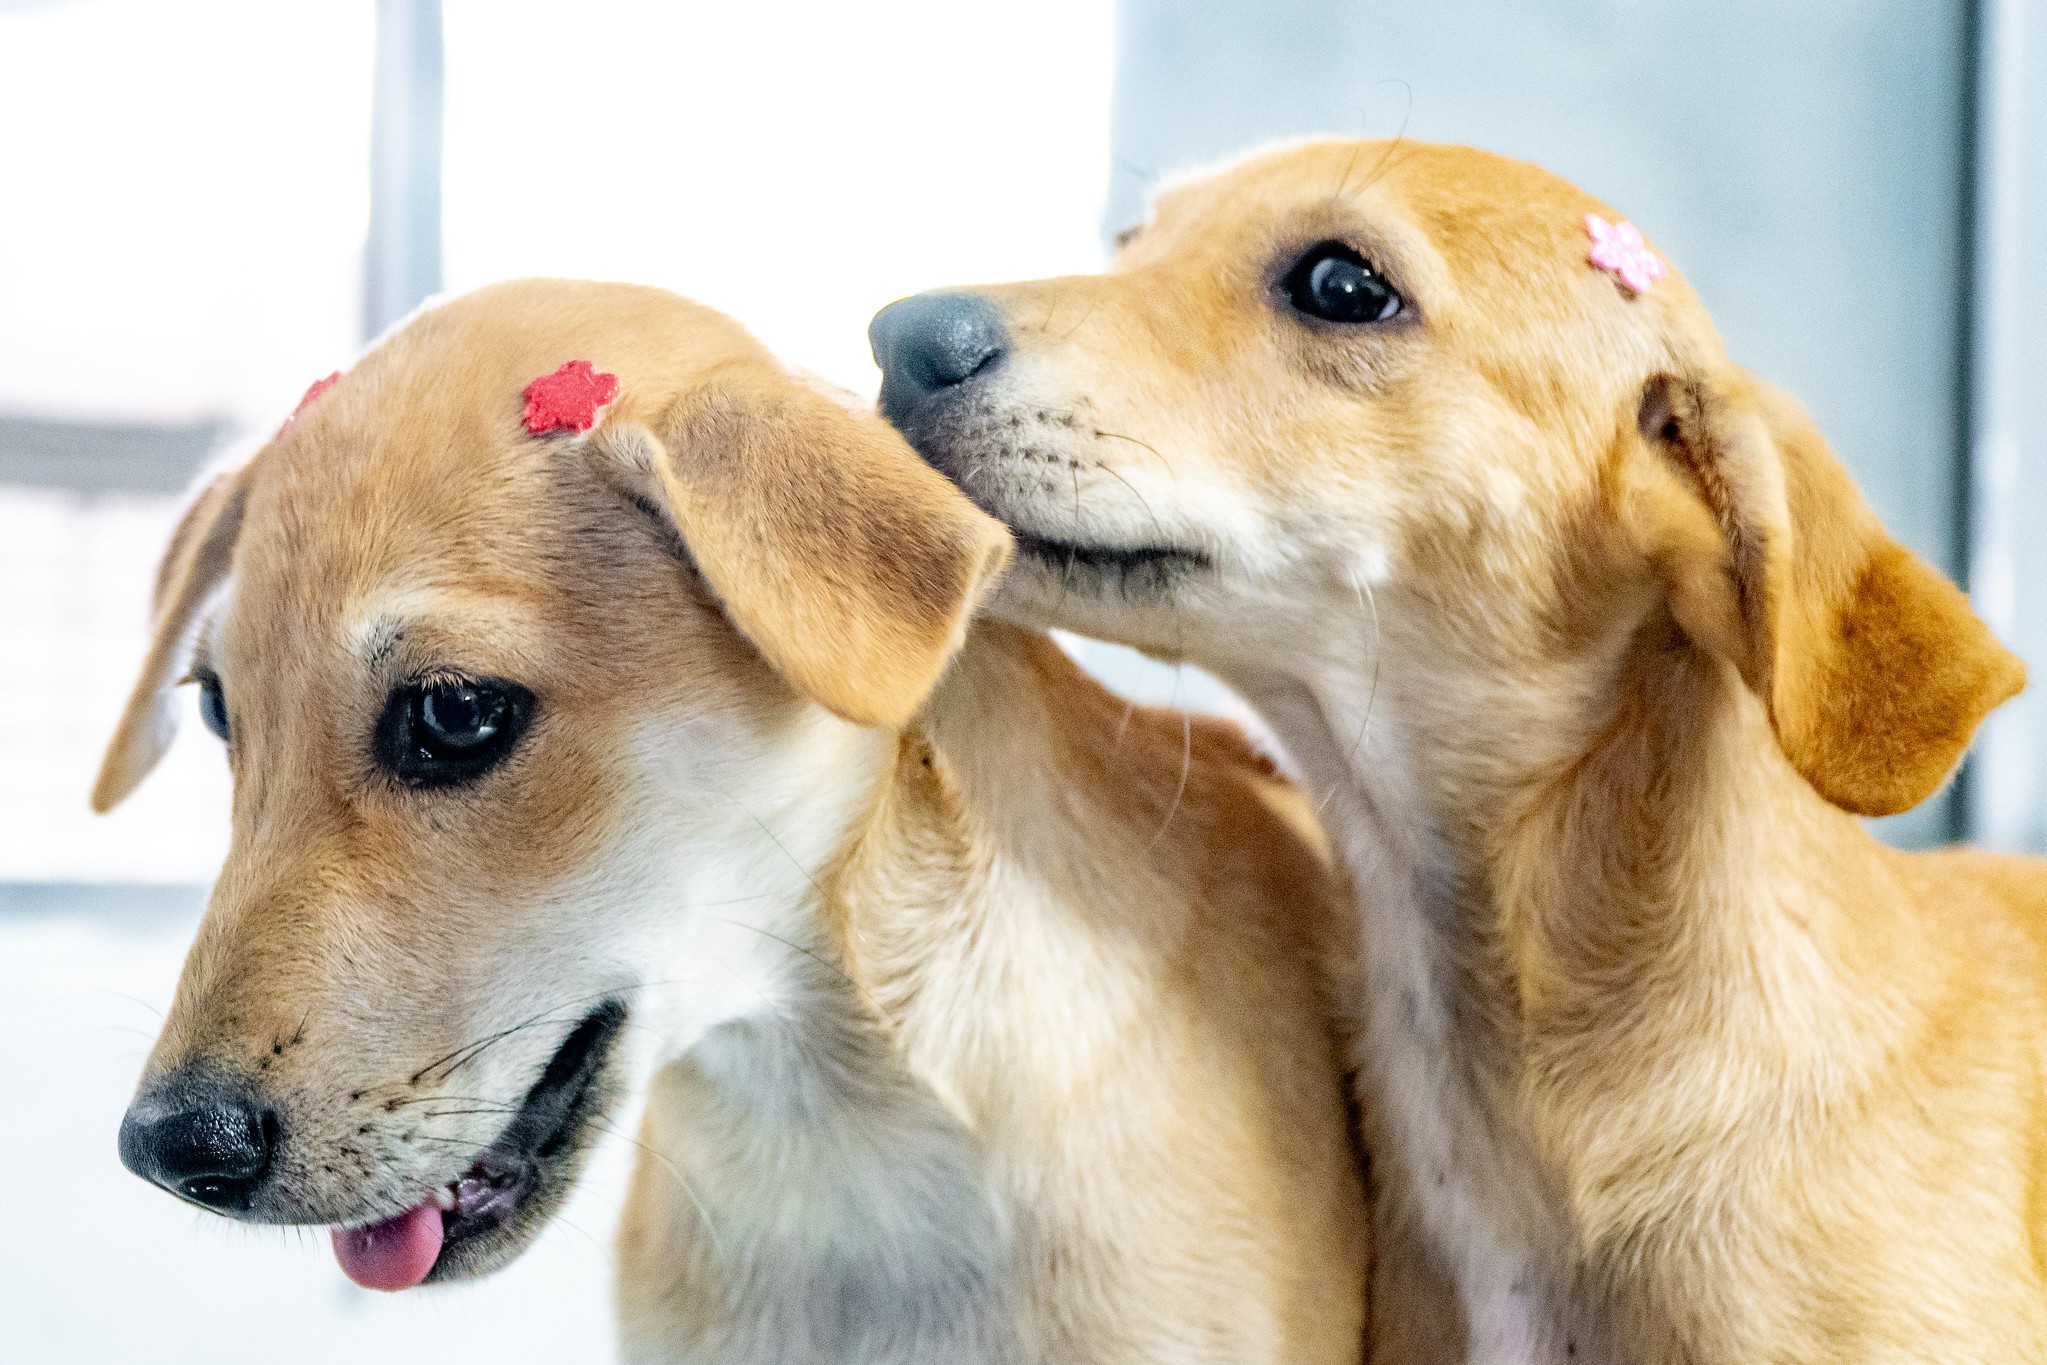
[[620, 641, 1363, 1365]]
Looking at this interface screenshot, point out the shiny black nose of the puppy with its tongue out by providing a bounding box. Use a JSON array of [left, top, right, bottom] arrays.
[[121, 1068, 278, 1212]]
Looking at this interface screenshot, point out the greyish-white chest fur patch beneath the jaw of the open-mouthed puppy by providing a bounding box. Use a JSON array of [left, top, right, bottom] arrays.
[[620, 994, 1021, 1365]]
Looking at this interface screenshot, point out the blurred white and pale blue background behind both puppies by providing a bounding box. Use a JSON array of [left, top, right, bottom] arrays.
[[0, 0, 2047, 1365]]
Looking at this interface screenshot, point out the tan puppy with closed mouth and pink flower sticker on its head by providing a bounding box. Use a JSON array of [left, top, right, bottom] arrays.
[[874, 143, 2047, 1363]]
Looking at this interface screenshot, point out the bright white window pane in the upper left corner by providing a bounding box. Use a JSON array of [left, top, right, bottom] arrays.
[[0, 0, 373, 430]]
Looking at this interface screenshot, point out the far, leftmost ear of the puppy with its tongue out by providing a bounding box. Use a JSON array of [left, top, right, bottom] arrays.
[[92, 469, 246, 814]]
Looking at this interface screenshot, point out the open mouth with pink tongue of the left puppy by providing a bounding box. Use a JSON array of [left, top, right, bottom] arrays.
[[334, 1001, 626, 1289]]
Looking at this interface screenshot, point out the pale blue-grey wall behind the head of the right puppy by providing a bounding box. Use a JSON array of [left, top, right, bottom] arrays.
[[1103, 0, 2047, 843]]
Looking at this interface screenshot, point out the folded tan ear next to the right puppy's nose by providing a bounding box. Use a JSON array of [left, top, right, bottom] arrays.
[[594, 381, 1009, 726]]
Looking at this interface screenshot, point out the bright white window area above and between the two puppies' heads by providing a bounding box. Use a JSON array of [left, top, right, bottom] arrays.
[[444, 0, 1114, 393]]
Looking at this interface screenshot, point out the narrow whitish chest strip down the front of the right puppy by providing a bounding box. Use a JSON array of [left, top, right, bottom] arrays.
[[1247, 688, 1625, 1365]]
